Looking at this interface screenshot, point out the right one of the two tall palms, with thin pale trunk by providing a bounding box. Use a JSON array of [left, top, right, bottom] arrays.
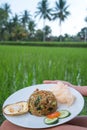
[[52, 0, 70, 41]]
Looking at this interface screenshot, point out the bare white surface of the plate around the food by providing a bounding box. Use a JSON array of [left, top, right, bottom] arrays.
[[3, 84, 84, 128]]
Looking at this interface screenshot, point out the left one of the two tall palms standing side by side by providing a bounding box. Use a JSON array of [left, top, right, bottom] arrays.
[[35, 0, 52, 41]]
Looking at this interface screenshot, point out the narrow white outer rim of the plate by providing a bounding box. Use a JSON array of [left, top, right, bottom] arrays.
[[3, 84, 84, 129]]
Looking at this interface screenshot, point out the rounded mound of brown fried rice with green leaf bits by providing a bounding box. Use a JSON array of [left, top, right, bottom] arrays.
[[28, 89, 57, 116]]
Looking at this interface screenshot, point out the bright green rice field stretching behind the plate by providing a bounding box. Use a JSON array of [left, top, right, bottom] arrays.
[[0, 46, 87, 122]]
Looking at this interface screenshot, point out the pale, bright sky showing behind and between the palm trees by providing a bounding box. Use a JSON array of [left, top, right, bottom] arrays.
[[0, 0, 87, 36]]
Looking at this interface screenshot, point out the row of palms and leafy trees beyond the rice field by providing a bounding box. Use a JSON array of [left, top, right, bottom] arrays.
[[0, 0, 87, 41]]
